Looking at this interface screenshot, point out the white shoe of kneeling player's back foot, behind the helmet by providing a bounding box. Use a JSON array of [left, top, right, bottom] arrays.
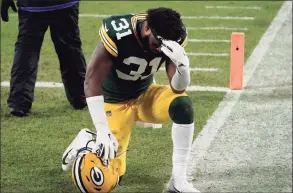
[[62, 129, 93, 171]]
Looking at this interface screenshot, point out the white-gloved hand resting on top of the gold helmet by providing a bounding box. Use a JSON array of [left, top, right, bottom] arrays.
[[95, 129, 118, 160]]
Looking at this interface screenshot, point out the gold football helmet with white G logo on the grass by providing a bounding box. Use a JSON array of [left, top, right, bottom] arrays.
[[72, 153, 119, 193]]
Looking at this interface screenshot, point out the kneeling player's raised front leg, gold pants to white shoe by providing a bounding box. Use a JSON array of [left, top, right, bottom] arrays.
[[138, 84, 197, 192]]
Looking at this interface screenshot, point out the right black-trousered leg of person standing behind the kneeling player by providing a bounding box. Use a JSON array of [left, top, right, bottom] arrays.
[[50, 5, 86, 109]]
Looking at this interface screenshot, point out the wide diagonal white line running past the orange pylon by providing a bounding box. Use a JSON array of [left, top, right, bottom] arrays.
[[189, 1, 292, 178]]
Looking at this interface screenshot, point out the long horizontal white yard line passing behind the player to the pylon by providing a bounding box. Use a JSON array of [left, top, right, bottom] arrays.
[[1, 81, 230, 92]]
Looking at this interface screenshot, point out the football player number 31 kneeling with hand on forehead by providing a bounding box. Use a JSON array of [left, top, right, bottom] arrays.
[[62, 7, 199, 192]]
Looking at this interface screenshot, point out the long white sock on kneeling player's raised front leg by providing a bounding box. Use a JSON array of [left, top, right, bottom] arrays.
[[172, 123, 194, 185]]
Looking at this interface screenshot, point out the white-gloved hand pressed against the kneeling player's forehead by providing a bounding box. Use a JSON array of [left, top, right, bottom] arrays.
[[161, 40, 189, 70]]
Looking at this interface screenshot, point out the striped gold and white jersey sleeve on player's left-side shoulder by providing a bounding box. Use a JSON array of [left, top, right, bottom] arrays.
[[99, 17, 118, 57]]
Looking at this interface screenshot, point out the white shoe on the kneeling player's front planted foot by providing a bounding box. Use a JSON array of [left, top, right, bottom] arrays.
[[163, 179, 200, 193]]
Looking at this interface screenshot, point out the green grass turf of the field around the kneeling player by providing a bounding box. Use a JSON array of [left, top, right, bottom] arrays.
[[1, 1, 281, 193]]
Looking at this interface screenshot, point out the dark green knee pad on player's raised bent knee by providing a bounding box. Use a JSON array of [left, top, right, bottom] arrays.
[[169, 96, 194, 124]]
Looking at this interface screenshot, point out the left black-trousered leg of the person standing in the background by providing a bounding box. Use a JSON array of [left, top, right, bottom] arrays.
[[7, 9, 48, 117]]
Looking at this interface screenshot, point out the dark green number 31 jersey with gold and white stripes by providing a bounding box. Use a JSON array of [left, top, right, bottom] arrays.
[[99, 14, 187, 103]]
